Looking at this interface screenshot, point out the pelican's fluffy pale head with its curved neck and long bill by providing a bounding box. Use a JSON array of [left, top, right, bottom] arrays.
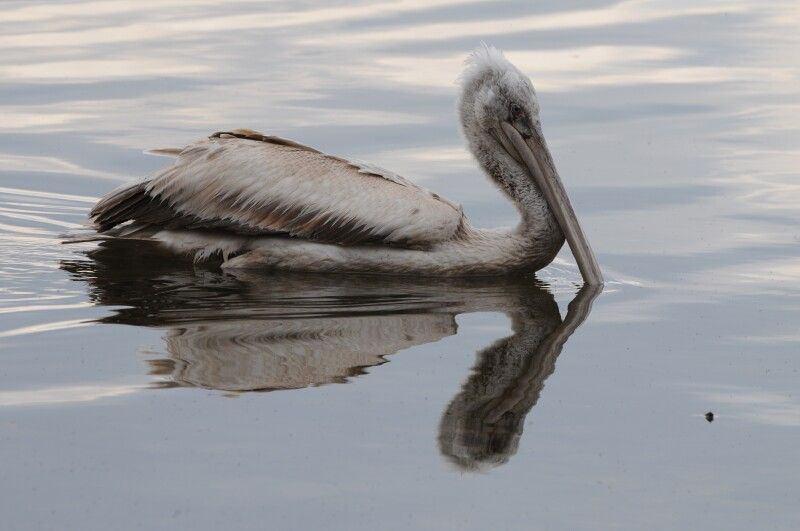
[[459, 45, 603, 284]]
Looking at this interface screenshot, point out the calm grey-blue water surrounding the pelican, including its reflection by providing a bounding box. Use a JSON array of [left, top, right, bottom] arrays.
[[0, 0, 800, 530]]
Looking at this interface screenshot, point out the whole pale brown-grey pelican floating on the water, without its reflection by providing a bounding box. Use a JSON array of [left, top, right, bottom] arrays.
[[91, 46, 603, 285]]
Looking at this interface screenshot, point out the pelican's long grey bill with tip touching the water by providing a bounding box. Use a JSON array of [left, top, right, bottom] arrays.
[[500, 122, 603, 285]]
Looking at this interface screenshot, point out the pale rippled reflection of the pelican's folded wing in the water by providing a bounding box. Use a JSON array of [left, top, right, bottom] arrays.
[[151, 315, 454, 391]]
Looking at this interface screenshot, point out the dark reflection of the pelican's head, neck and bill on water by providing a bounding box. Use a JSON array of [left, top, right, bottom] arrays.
[[439, 286, 599, 471]]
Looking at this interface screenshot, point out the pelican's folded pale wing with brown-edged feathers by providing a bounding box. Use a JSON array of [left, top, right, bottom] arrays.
[[91, 129, 464, 246]]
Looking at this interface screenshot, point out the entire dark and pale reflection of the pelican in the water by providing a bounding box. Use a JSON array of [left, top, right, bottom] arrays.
[[62, 241, 599, 470]]
